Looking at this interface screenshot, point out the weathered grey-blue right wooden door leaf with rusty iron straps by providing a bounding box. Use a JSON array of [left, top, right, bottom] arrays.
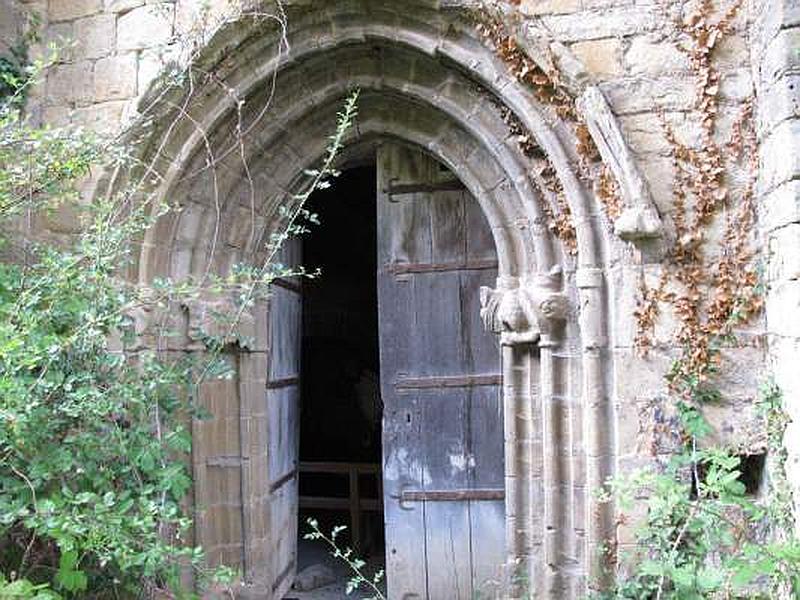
[[378, 143, 505, 600]]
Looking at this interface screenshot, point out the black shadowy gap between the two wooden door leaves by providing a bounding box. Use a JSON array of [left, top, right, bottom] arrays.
[[286, 164, 384, 600]]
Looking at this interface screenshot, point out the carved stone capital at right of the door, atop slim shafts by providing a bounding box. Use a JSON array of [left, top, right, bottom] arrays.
[[481, 269, 569, 346]]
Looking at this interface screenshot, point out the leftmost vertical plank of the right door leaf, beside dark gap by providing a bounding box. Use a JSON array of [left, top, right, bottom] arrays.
[[377, 144, 430, 599]]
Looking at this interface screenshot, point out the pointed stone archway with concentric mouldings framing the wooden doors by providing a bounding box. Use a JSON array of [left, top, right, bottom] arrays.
[[115, 0, 652, 598]]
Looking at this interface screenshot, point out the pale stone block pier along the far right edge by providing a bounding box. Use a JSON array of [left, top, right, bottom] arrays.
[[753, 0, 800, 518]]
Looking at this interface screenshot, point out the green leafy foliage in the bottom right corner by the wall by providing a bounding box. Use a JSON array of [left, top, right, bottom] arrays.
[[600, 385, 800, 600]]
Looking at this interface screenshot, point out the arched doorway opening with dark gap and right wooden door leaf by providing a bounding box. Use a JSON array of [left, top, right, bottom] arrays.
[[288, 145, 505, 599]]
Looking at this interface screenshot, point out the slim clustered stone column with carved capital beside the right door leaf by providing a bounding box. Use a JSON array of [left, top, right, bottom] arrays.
[[481, 269, 568, 598]]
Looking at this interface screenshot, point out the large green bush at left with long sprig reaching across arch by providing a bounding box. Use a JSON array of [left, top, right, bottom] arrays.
[[0, 34, 357, 600]]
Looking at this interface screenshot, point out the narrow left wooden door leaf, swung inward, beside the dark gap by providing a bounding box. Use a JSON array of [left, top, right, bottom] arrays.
[[266, 239, 302, 599]]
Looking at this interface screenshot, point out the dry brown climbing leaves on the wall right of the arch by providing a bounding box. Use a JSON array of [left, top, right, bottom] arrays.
[[636, 0, 761, 393]]
